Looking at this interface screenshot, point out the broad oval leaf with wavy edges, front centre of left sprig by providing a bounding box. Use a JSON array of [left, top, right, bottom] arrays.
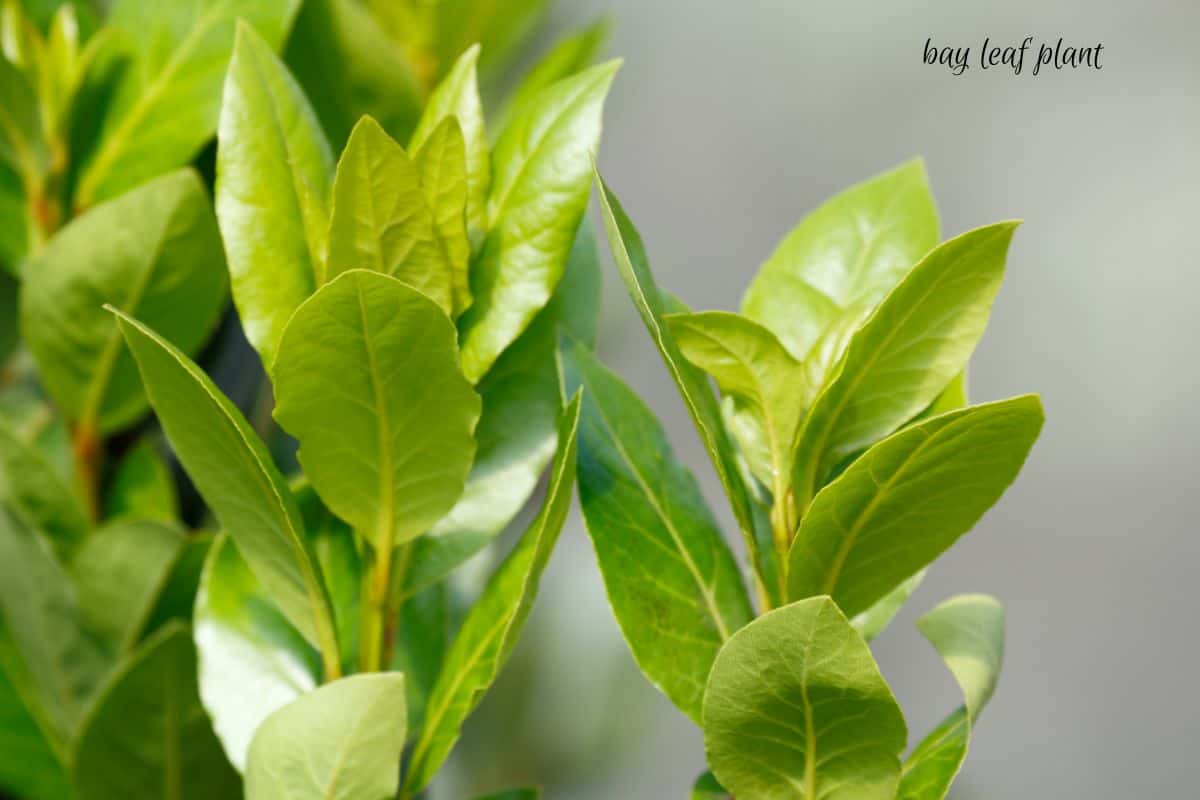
[[275, 268, 480, 553]]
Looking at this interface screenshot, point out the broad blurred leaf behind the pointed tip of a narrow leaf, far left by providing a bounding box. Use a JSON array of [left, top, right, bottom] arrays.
[[20, 170, 227, 433]]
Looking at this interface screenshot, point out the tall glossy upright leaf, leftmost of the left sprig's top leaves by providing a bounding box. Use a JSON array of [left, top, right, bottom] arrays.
[[216, 25, 334, 368]]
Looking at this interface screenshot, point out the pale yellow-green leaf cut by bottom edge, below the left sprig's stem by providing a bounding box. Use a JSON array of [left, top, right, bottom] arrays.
[[246, 673, 406, 800]]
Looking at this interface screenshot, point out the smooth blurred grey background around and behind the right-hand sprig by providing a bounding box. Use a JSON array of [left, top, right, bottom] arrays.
[[440, 0, 1200, 800]]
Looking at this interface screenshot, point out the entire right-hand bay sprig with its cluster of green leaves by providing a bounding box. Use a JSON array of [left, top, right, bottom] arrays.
[[560, 162, 1043, 800]]
